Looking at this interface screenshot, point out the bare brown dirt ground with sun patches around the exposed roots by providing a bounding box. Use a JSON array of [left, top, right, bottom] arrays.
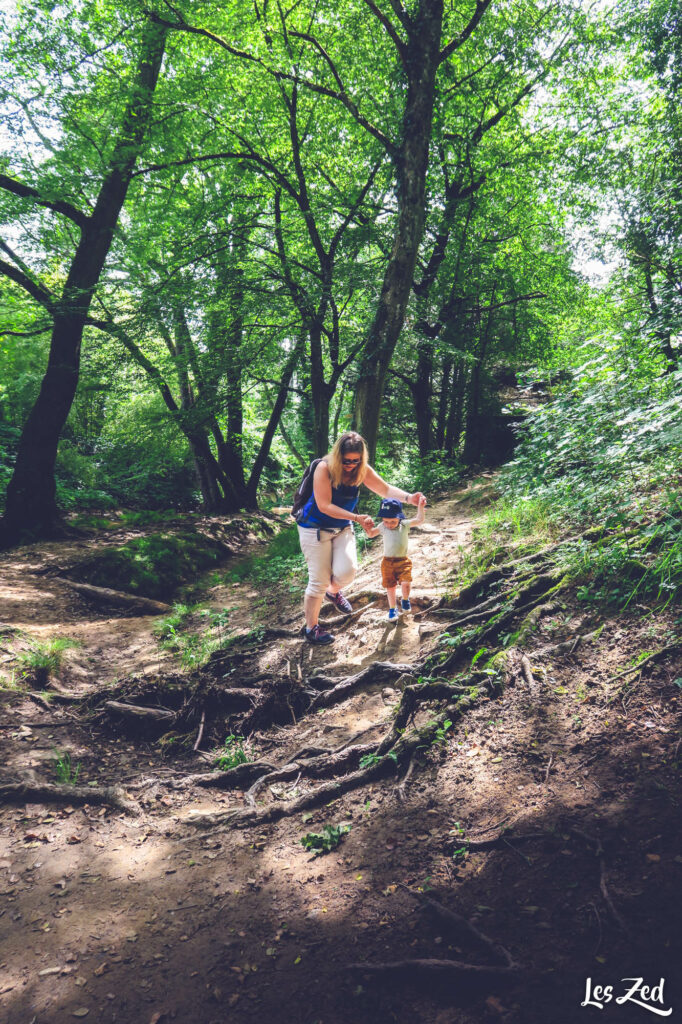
[[0, 493, 682, 1024]]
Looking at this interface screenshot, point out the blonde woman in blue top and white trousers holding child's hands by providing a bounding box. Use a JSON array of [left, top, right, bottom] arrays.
[[298, 430, 426, 644]]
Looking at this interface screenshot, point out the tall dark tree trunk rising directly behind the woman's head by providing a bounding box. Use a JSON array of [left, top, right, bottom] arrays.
[[353, 0, 443, 460]]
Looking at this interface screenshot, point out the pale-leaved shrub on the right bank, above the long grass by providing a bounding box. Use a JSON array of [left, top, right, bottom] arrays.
[[500, 345, 682, 526]]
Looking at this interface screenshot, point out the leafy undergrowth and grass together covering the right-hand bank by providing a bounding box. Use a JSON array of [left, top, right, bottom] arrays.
[[457, 343, 682, 611]]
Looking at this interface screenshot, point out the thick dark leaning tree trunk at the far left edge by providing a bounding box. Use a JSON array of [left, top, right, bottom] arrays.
[[0, 20, 168, 548]]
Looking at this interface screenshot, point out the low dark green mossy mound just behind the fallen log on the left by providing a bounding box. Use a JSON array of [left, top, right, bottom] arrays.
[[78, 531, 224, 600]]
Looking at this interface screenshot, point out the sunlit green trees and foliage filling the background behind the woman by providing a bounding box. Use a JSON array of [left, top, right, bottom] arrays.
[[0, 0, 682, 547]]
